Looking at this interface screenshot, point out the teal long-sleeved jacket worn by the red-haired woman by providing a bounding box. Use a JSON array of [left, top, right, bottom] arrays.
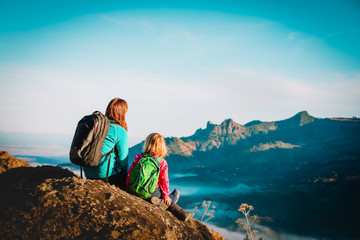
[[84, 120, 129, 178]]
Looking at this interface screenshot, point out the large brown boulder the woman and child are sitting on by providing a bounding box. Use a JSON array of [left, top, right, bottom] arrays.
[[0, 158, 223, 239]]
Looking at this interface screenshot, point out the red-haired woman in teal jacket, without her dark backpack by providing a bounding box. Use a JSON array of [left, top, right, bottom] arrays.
[[84, 98, 129, 188]]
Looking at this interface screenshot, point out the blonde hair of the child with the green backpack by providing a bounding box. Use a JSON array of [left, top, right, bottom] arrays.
[[143, 133, 166, 157]]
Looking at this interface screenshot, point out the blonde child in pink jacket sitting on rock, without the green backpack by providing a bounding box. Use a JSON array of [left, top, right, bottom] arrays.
[[126, 133, 194, 221]]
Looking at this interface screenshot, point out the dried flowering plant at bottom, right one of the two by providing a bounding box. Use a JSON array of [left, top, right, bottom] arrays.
[[236, 203, 262, 240]]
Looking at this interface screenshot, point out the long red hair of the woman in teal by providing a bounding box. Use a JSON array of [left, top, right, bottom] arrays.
[[105, 98, 128, 131]]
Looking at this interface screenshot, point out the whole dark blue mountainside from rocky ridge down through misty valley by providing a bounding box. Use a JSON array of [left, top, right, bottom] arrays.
[[130, 111, 360, 239]]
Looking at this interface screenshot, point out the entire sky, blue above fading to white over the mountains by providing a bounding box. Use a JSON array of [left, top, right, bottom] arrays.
[[0, 0, 360, 155]]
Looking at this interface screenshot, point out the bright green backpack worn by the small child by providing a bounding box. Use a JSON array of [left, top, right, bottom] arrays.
[[129, 154, 161, 199]]
